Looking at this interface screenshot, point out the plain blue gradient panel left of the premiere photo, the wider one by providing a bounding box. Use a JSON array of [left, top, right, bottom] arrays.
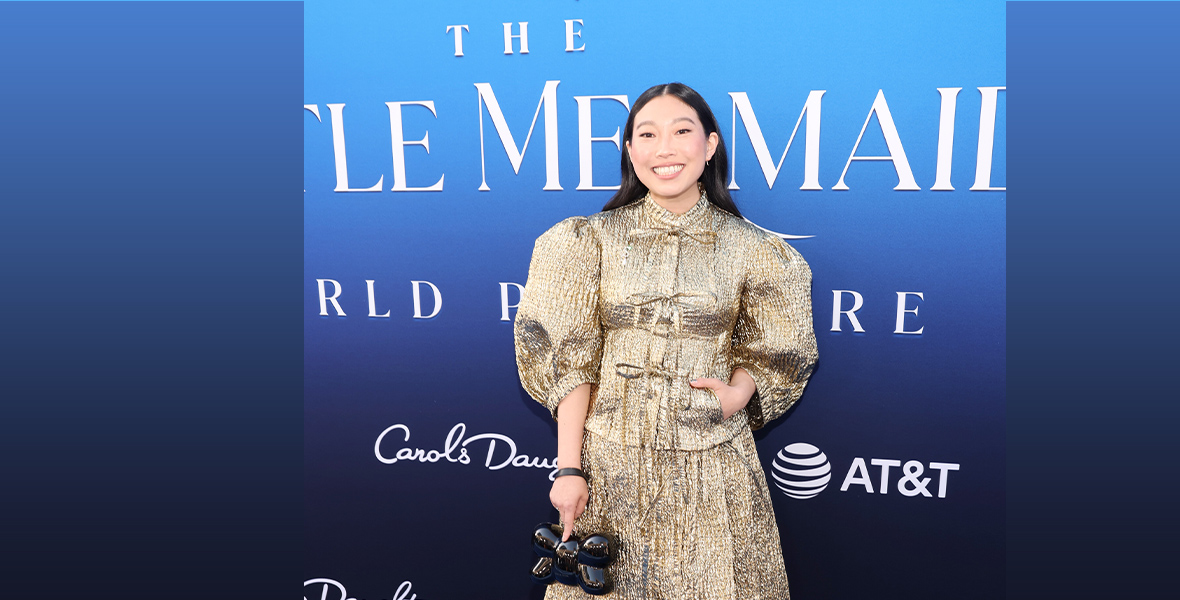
[[0, 2, 303, 600]]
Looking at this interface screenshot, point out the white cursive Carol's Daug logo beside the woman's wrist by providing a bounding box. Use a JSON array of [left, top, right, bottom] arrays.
[[377, 423, 557, 479]]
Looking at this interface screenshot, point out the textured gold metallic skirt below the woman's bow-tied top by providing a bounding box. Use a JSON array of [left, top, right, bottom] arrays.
[[545, 429, 791, 600]]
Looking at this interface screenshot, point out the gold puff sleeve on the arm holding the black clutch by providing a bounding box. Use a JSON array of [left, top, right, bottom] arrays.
[[514, 217, 603, 418]]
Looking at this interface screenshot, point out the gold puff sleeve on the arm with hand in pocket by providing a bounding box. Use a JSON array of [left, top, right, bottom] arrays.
[[733, 234, 818, 429]]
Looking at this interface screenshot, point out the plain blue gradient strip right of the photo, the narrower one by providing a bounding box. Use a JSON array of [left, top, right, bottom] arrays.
[[1007, 2, 1180, 599]]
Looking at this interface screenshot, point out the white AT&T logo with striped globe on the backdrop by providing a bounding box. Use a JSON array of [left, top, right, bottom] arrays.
[[771, 442, 959, 500]]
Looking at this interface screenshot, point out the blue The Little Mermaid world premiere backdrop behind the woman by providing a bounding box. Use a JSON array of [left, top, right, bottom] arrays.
[[303, 0, 1007, 600]]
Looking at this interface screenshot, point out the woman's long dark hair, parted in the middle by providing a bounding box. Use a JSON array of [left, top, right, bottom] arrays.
[[602, 83, 741, 217]]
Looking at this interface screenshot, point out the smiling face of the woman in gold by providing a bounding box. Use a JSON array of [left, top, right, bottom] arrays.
[[627, 96, 717, 211]]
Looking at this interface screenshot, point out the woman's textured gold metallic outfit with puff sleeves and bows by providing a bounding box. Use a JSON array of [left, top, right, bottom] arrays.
[[516, 195, 817, 600]]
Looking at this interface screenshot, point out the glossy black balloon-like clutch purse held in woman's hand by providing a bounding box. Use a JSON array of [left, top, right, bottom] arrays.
[[531, 523, 617, 595]]
